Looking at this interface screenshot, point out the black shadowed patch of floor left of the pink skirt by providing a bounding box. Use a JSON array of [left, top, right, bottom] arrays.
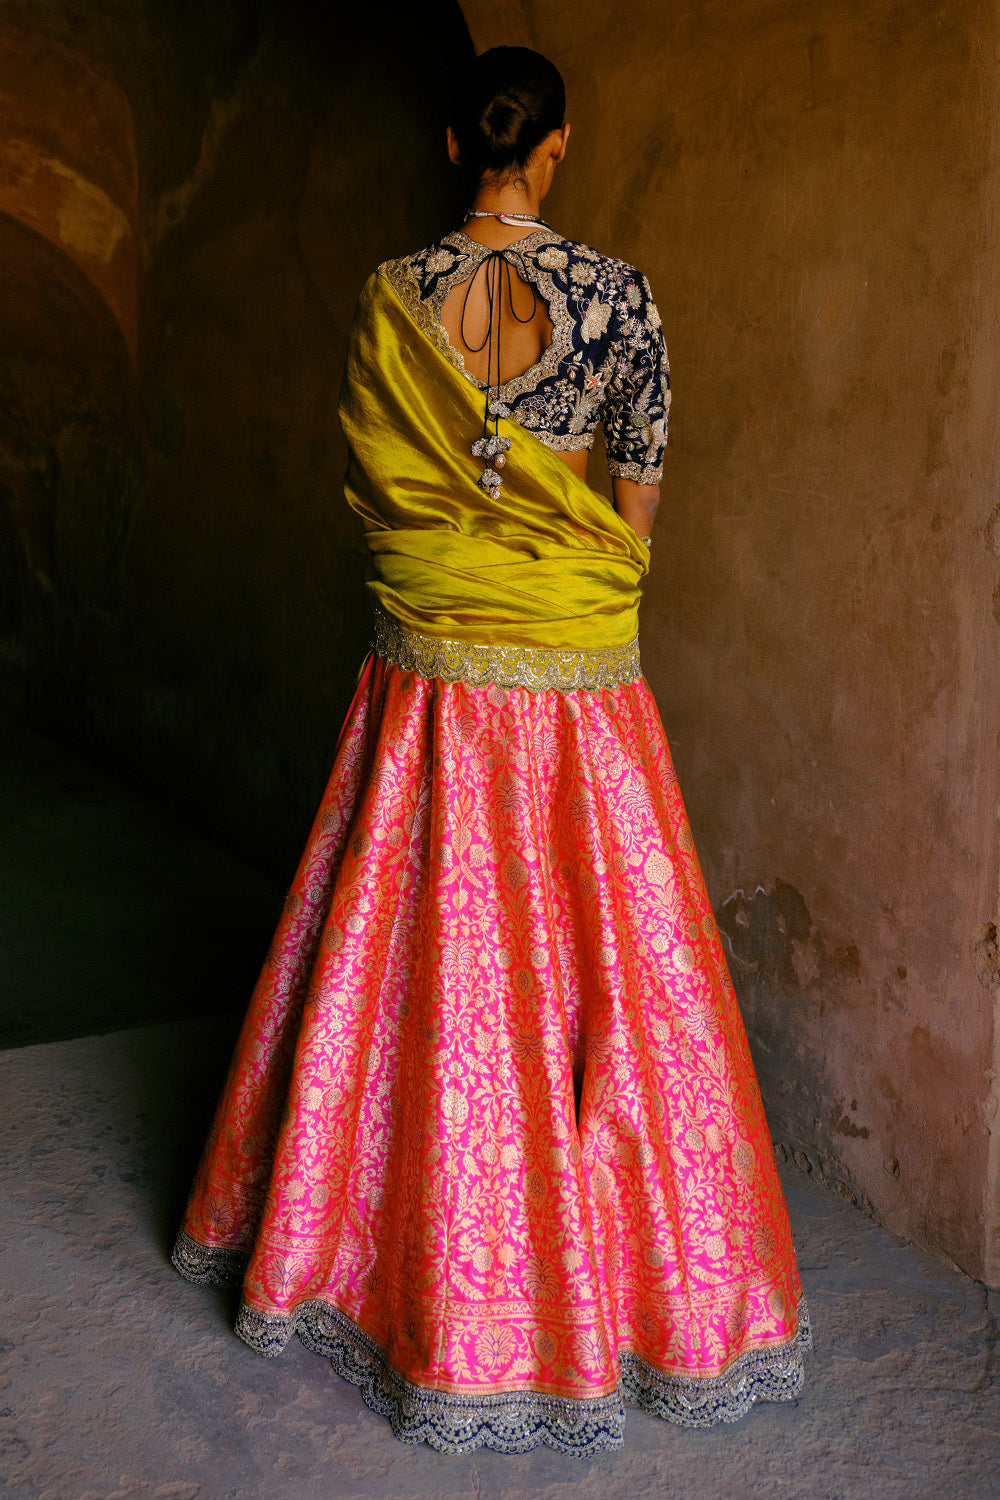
[[0, 716, 281, 1049]]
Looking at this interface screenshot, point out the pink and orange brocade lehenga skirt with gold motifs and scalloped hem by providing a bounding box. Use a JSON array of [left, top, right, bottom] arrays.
[[174, 624, 808, 1454]]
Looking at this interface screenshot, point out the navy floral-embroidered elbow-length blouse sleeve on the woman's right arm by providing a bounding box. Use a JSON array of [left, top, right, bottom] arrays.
[[601, 272, 670, 485]]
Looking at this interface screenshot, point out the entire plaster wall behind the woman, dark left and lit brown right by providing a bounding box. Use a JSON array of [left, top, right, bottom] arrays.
[[0, 0, 1000, 1281]]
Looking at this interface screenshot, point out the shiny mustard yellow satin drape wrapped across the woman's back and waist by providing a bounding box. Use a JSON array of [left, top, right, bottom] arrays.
[[340, 269, 648, 650]]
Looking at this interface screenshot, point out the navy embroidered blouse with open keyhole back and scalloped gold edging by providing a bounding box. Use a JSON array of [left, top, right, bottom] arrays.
[[382, 230, 670, 485]]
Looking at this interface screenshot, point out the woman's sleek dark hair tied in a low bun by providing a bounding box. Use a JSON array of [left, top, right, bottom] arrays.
[[450, 47, 565, 179]]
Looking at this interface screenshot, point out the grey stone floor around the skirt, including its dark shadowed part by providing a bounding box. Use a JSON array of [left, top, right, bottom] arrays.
[[0, 711, 1000, 1500]]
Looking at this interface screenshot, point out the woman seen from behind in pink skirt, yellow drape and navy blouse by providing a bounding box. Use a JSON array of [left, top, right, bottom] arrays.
[[174, 48, 808, 1454]]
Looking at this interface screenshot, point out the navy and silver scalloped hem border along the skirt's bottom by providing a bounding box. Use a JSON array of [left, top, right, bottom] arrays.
[[172, 1230, 813, 1458]]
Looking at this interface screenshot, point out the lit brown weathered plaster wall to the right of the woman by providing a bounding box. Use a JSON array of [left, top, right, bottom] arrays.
[[463, 0, 1000, 1281]]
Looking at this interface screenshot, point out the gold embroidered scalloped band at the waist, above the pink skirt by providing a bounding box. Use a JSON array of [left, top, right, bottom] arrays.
[[372, 605, 642, 693]]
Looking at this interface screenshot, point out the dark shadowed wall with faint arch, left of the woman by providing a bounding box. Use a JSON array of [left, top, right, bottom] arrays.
[[0, 0, 472, 878]]
